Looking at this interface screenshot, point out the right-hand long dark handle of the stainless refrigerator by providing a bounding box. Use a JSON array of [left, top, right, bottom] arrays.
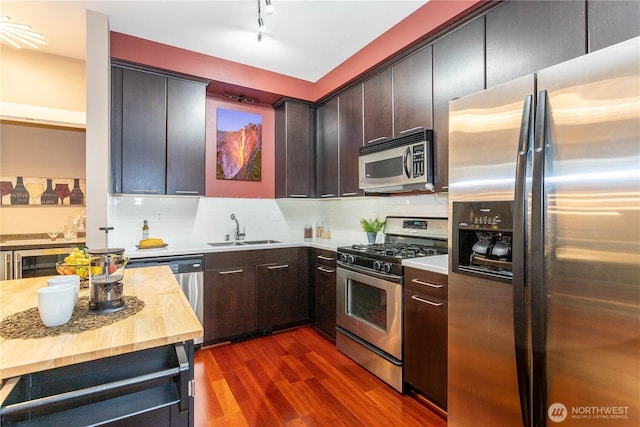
[[528, 90, 551, 425]]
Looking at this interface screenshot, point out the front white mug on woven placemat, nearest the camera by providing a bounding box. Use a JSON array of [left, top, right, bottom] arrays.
[[38, 283, 76, 327]]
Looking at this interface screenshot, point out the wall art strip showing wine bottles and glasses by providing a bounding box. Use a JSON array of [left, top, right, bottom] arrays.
[[0, 176, 87, 206]]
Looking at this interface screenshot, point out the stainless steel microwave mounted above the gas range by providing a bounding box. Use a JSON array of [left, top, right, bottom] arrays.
[[358, 129, 434, 193]]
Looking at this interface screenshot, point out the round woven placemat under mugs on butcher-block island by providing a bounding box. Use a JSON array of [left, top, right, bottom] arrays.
[[0, 295, 144, 339]]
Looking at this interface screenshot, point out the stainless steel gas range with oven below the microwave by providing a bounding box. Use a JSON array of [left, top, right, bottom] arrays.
[[336, 216, 448, 393]]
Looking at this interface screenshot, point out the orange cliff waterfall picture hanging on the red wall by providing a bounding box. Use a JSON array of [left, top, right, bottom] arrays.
[[216, 108, 262, 181]]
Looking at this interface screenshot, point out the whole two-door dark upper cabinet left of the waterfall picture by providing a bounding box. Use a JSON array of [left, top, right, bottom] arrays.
[[111, 66, 206, 195]]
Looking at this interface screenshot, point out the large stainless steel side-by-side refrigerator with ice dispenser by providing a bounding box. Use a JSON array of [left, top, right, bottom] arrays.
[[448, 38, 640, 427]]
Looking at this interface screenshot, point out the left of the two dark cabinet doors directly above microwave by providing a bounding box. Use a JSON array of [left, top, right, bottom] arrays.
[[363, 68, 393, 144]]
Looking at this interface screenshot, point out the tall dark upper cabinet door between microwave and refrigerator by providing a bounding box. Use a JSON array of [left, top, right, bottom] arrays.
[[433, 17, 484, 191]]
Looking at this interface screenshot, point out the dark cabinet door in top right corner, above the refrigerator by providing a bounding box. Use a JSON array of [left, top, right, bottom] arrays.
[[587, 0, 640, 52]]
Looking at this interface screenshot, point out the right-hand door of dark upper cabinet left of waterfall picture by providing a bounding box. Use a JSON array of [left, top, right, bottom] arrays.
[[167, 78, 206, 195]]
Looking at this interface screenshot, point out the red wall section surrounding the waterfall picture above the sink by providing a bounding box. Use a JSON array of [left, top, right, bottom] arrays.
[[205, 98, 275, 199]]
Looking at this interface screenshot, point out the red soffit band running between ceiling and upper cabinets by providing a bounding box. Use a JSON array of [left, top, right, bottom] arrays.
[[110, 0, 486, 102]]
